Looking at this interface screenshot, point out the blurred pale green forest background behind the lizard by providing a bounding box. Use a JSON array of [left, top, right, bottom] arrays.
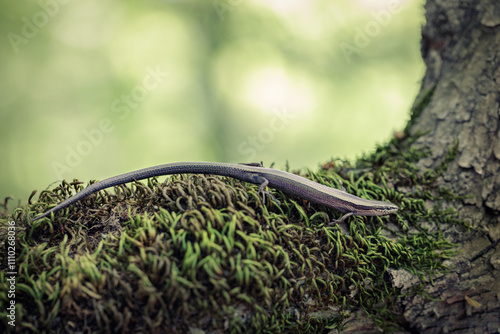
[[0, 0, 424, 202]]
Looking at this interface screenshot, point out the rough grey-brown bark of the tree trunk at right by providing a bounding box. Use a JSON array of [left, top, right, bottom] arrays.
[[402, 0, 500, 333]]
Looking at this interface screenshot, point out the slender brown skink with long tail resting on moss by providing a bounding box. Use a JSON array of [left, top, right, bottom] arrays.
[[34, 162, 398, 223]]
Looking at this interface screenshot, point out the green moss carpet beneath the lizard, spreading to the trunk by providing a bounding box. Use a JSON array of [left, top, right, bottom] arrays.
[[0, 135, 463, 333]]
